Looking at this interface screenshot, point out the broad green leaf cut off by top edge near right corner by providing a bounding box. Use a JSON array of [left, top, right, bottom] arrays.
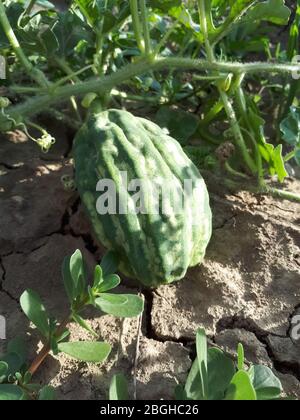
[[245, 0, 291, 25]]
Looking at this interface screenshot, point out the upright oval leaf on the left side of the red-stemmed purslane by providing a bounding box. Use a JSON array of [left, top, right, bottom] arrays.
[[20, 289, 50, 338]]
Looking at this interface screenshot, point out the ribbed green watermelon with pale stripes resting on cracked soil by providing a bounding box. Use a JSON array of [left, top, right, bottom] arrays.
[[73, 110, 212, 287]]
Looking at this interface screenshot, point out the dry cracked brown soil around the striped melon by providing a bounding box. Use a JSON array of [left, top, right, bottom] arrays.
[[0, 127, 300, 400]]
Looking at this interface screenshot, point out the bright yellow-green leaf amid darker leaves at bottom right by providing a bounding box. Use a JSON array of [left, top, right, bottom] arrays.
[[225, 370, 257, 401]]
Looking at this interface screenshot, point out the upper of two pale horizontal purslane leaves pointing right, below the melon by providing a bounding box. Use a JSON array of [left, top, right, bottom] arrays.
[[95, 293, 144, 318]]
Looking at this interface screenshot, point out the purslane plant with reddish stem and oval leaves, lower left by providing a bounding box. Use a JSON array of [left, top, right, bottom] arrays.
[[0, 250, 144, 400]]
